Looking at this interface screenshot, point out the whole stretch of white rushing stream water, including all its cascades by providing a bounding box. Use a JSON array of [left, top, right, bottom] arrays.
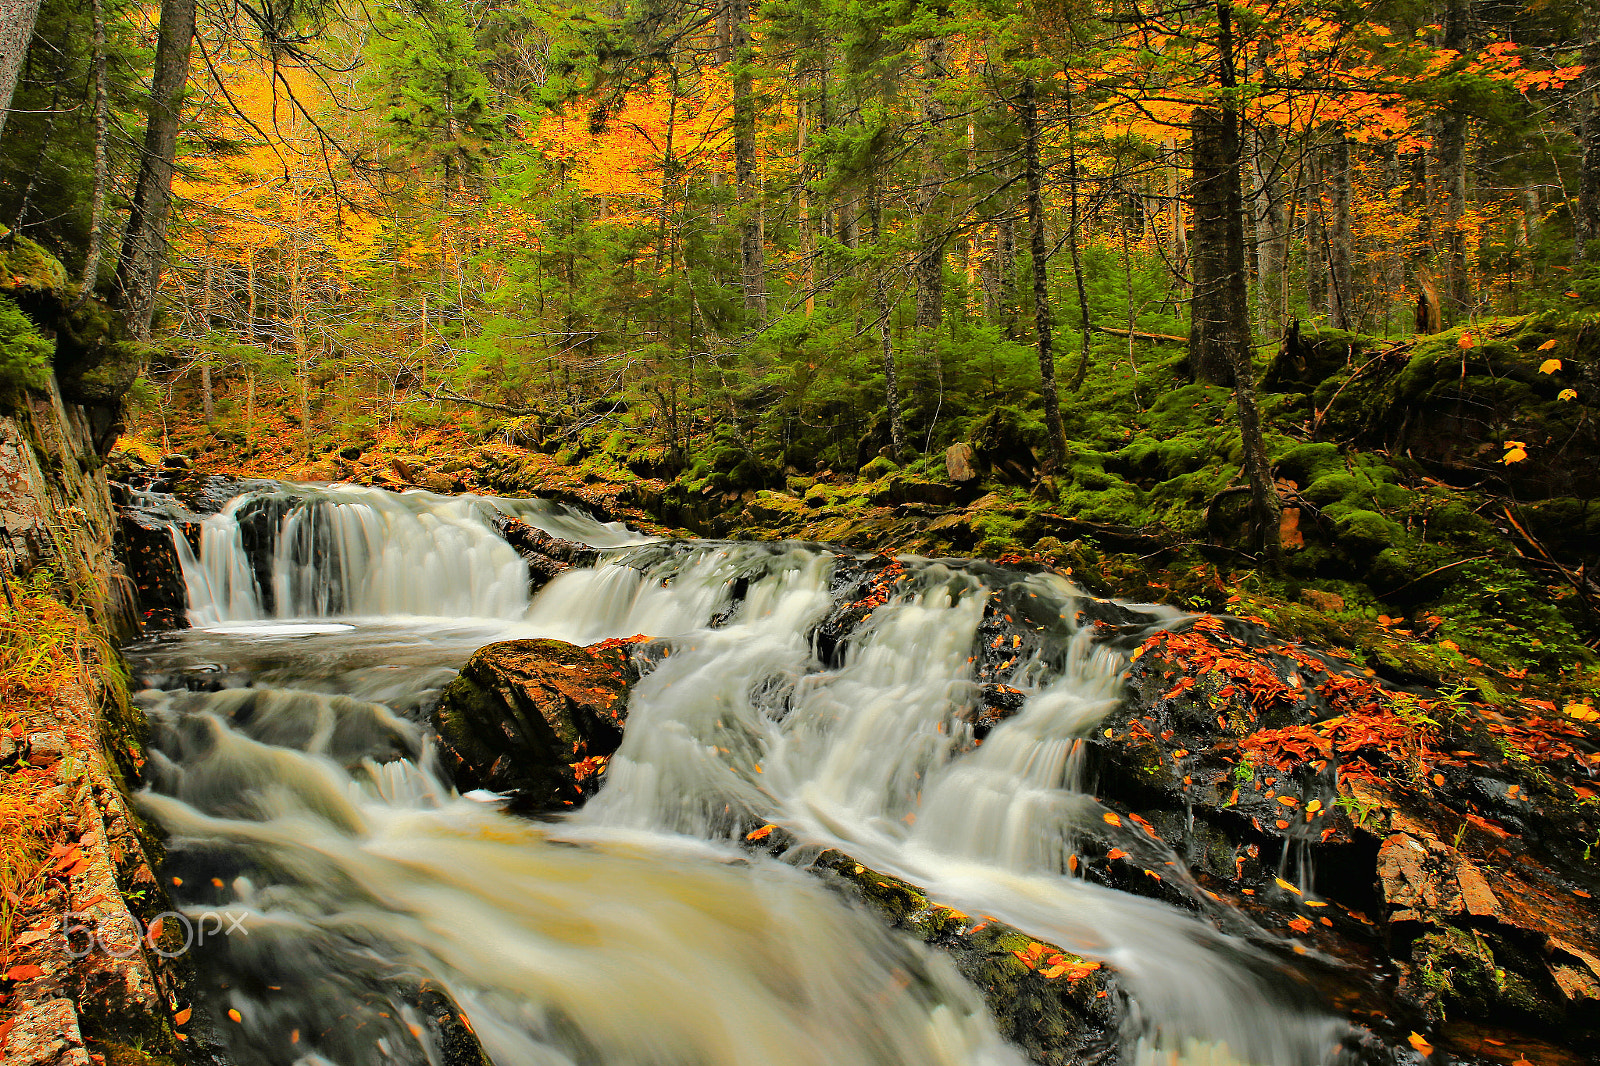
[[130, 487, 1344, 1066]]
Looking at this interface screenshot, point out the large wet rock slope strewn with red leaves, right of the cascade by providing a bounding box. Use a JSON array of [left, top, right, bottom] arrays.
[[1082, 618, 1600, 1056]]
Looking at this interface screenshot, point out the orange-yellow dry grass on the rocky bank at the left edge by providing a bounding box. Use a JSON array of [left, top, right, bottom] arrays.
[[0, 584, 93, 973]]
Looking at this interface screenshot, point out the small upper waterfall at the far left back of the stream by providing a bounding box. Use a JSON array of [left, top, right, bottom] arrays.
[[164, 485, 642, 626]]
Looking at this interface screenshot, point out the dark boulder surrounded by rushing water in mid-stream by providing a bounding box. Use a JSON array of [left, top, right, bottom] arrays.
[[434, 640, 638, 813]]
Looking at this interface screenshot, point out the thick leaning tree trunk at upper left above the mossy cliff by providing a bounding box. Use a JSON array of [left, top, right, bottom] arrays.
[[117, 0, 195, 339]]
